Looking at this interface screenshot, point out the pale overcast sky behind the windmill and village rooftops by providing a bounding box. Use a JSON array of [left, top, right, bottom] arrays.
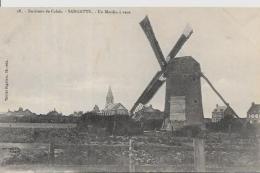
[[0, 8, 260, 117]]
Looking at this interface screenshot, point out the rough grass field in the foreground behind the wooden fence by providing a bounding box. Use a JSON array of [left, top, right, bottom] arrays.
[[0, 123, 260, 172]]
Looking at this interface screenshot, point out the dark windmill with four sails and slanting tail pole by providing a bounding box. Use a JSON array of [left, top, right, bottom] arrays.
[[130, 16, 238, 125]]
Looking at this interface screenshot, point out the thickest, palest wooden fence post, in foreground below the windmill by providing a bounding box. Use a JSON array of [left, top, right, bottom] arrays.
[[193, 138, 206, 172]]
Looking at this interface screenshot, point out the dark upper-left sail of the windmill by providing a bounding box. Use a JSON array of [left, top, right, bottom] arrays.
[[140, 16, 167, 69]]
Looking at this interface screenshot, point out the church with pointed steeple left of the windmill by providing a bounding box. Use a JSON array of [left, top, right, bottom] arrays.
[[102, 86, 128, 115]]
